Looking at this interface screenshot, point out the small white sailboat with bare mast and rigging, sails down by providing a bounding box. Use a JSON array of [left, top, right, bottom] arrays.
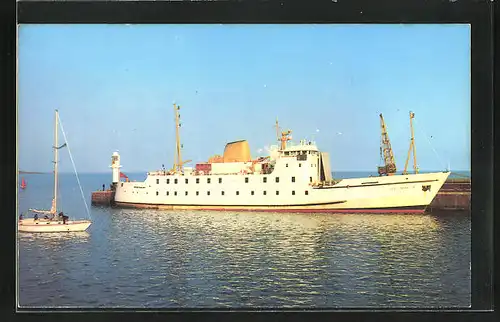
[[17, 110, 92, 233]]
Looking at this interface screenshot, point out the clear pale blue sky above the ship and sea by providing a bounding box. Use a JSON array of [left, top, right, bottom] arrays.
[[18, 25, 470, 172]]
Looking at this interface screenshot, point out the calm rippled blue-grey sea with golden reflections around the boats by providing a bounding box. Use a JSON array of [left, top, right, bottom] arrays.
[[18, 174, 471, 308]]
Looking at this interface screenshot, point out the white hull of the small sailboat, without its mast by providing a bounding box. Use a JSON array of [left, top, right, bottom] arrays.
[[17, 218, 92, 233]]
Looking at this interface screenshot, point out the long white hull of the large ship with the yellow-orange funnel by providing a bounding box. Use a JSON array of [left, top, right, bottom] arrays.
[[115, 172, 449, 213]]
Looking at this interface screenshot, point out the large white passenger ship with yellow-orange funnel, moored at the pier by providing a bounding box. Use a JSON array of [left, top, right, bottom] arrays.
[[111, 105, 450, 213]]
